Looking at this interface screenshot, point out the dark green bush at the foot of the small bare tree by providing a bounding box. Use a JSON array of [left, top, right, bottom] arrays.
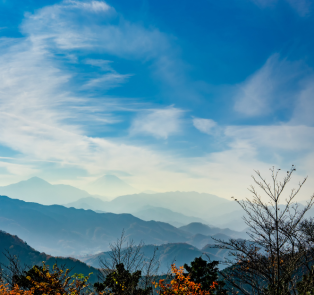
[[94, 263, 152, 295]]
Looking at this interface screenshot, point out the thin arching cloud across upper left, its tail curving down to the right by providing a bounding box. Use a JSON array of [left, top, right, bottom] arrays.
[[21, 1, 196, 104]]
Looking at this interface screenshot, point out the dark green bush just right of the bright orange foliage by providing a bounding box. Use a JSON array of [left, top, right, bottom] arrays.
[[184, 257, 227, 295]]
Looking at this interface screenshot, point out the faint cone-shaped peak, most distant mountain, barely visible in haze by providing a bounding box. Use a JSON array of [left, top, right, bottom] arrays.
[[86, 175, 138, 197]]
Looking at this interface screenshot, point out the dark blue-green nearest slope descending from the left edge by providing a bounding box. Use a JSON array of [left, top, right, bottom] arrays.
[[0, 230, 97, 281]]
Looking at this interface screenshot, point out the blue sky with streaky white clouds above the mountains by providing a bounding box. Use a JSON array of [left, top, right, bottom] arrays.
[[0, 0, 314, 199]]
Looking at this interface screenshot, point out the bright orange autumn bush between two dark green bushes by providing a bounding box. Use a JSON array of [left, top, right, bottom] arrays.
[[155, 264, 218, 295]]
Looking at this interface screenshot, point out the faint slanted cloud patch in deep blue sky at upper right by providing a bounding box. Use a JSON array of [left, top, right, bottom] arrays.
[[234, 54, 306, 117]]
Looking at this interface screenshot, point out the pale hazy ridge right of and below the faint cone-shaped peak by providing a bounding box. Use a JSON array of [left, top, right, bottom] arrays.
[[65, 192, 242, 231]]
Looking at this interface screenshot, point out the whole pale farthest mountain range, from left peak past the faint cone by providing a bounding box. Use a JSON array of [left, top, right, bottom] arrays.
[[0, 175, 246, 231]]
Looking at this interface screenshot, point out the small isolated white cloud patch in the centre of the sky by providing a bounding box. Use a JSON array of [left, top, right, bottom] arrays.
[[130, 107, 183, 139]]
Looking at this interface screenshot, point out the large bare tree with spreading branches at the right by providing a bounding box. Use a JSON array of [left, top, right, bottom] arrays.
[[214, 166, 314, 295]]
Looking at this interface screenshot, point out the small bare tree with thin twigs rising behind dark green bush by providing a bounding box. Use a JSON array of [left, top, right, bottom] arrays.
[[98, 230, 160, 289]]
